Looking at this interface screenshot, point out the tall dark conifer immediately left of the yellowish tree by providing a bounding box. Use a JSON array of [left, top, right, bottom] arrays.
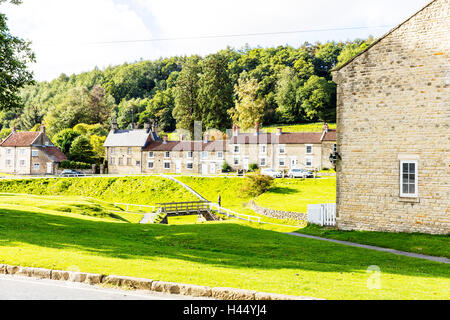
[[198, 54, 233, 131]]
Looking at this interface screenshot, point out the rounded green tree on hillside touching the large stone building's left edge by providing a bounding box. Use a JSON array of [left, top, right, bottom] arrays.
[[297, 76, 336, 122]]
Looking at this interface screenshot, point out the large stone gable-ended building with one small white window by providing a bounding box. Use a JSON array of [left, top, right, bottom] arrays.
[[333, 0, 450, 234]]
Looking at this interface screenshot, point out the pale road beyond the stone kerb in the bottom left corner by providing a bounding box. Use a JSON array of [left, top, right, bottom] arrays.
[[0, 274, 214, 300]]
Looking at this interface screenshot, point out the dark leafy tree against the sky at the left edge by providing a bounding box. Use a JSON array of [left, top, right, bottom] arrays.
[[0, 0, 35, 109]]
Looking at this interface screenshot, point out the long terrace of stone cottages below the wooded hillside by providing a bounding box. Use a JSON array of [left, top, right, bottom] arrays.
[[104, 125, 336, 174]]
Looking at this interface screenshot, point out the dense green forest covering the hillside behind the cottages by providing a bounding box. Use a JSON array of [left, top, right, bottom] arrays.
[[0, 38, 373, 160]]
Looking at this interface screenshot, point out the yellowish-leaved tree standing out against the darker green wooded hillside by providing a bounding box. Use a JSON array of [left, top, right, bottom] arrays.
[[228, 75, 264, 130]]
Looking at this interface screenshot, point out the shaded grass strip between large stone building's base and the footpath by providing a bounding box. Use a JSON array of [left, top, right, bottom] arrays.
[[297, 225, 450, 258]]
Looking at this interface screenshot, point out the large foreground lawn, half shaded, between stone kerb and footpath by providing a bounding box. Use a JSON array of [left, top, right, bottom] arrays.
[[0, 200, 450, 299]]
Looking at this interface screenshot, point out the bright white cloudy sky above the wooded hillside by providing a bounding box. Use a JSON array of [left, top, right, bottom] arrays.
[[0, 0, 430, 81]]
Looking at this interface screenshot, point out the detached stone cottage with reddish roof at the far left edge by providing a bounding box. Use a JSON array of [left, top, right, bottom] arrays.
[[0, 125, 67, 175]]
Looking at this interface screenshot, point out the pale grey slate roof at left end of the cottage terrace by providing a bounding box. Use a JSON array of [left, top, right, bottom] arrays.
[[103, 129, 155, 148]]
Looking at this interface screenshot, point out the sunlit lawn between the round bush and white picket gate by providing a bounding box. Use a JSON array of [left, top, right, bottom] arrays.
[[255, 177, 336, 212]]
